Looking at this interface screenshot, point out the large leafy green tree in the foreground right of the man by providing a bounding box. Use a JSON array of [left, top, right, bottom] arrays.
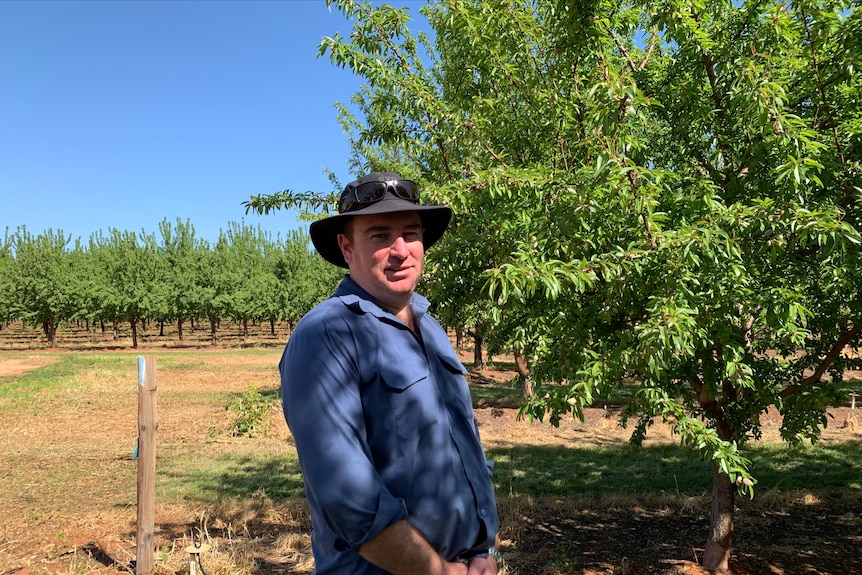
[[306, 0, 862, 571]]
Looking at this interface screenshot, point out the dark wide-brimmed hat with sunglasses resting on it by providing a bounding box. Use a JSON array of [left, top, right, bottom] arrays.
[[309, 172, 452, 268]]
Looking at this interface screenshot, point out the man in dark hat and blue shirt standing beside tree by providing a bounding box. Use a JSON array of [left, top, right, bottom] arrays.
[[279, 172, 499, 575]]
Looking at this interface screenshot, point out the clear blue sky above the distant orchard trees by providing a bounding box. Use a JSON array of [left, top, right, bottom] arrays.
[[0, 0, 422, 242]]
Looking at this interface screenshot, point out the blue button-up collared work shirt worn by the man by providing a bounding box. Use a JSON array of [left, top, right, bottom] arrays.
[[279, 276, 499, 575]]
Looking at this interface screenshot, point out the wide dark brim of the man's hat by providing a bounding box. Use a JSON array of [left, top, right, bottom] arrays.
[[309, 196, 452, 268]]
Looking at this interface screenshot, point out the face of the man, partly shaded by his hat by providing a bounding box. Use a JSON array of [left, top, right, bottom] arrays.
[[338, 212, 425, 311]]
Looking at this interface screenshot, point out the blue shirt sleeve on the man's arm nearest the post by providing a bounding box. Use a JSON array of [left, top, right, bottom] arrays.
[[279, 310, 407, 553]]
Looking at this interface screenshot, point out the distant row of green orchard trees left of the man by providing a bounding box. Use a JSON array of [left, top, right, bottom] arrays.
[[0, 219, 340, 347]]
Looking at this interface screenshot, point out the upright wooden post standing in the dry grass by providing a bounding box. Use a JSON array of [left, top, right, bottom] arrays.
[[135, 356, 159, 575]]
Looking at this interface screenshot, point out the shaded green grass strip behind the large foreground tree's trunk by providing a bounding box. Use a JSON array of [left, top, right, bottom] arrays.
[[488, 442, 862, 497]]
